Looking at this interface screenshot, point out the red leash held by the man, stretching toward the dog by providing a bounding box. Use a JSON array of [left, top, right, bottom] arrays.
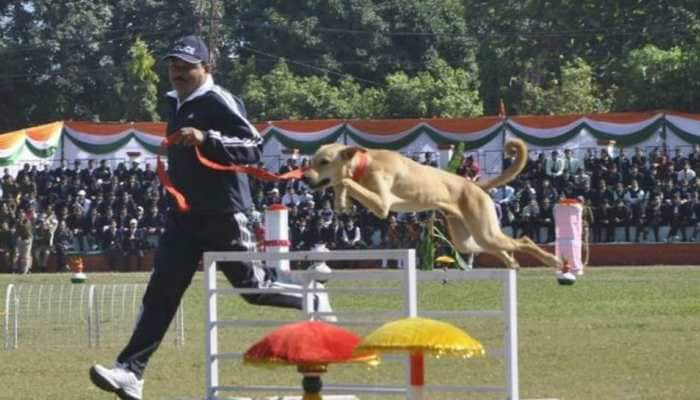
[[156, 131, 304, 213]]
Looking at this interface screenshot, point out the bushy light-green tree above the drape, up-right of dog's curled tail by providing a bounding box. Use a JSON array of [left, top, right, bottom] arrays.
[[518, 58, 612, 114]]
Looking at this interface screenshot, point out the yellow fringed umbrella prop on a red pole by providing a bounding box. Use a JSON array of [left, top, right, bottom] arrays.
[[355, 317, 485, 400]]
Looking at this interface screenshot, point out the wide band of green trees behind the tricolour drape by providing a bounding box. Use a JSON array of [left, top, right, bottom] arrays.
[[0, 0, 700, 131]]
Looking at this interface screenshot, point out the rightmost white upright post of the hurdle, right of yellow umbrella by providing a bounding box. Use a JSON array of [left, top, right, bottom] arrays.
[[503, 270, 520, 400]]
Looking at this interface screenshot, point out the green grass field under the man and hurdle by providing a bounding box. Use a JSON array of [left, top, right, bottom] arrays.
[[0, 267, 700, 400]]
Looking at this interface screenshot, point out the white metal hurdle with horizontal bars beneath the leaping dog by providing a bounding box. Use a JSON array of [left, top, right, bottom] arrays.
[[203, 249, 519, 400]]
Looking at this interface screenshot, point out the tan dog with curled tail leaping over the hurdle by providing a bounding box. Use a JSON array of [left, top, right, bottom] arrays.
[[304, 140, 561, 268]]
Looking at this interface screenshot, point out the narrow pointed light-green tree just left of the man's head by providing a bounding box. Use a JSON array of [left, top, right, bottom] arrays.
[[116, 39, 160, 121]]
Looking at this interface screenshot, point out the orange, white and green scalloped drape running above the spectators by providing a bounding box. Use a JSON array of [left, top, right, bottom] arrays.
[[0, 112, 700, 165]]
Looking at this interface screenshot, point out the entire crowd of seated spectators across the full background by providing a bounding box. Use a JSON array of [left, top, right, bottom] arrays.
[[0, 142, 700, 272]]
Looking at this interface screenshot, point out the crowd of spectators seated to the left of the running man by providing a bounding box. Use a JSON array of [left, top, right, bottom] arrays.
[[0, 160, 166, 273]]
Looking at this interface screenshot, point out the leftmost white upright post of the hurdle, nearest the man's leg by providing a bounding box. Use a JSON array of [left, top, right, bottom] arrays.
[[203, 253, 219, 400]]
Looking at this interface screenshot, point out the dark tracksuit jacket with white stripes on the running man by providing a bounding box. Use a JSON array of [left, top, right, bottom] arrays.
[[167, 76, 262, 214]]
